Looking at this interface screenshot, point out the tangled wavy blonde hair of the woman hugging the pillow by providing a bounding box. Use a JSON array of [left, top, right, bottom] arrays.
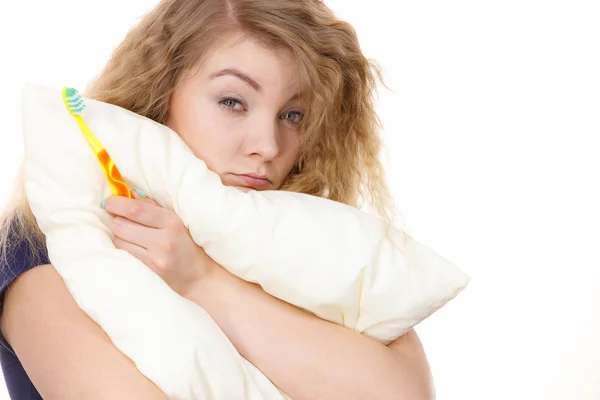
[[0, 0, 408, 268]]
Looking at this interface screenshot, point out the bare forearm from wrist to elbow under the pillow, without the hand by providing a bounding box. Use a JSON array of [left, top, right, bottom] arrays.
[[187, 267, 435, 400]]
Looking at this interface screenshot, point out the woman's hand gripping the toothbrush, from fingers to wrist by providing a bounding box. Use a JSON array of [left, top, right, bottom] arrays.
[[103, 189, 217, 297]]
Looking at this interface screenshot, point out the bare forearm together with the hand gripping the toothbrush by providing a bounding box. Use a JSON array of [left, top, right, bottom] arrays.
[[105, 192, 434, 400]]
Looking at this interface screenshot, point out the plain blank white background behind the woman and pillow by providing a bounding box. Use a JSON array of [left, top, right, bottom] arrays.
[[0, 0, 600, 400]]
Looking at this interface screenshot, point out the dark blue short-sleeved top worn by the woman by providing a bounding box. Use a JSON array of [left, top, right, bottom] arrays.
[[0, 227, 50, 400]]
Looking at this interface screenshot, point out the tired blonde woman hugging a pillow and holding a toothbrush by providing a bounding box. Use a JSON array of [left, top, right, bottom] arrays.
[[1, 0, 433, 400]]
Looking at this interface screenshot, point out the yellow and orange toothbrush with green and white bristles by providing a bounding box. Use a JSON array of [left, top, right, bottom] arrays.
[[62, 87, 133, 199]]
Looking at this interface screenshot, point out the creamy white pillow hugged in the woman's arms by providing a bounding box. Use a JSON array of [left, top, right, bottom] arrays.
[[23, 84, 469, 400]]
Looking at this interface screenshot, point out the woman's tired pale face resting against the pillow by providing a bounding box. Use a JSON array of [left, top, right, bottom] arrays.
[[166, 35, 304, 191]]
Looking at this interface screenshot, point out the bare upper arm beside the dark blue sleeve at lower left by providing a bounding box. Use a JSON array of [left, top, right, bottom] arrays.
[[0, 265, 167, 400]]
